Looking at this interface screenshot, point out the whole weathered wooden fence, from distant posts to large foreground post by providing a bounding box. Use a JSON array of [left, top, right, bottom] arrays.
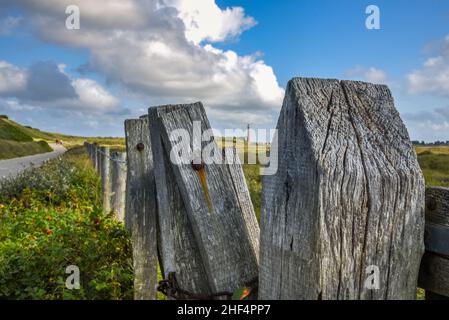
[[85, 78, 449, 300]]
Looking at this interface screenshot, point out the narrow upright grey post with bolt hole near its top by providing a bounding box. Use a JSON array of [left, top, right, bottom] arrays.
[[125, 119, 157, 300]]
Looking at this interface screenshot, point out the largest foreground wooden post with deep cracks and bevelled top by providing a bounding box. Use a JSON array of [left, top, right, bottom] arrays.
[[259, 78, 424, 299]]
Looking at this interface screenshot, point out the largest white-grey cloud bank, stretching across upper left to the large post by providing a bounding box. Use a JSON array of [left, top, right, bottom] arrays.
[[1, 0, 284, 130]]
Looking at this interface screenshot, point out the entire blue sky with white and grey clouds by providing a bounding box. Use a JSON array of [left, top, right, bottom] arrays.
[[0, 0, 449, 142]]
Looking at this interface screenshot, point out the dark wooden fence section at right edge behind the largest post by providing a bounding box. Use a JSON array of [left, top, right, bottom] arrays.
[[419, 187, 449, 300]]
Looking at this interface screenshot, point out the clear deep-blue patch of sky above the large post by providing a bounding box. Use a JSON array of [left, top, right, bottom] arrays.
[[218, 0, 449, 82]]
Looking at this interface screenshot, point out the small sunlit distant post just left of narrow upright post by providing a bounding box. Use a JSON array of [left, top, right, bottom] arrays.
[[111, 152, 127, 221]]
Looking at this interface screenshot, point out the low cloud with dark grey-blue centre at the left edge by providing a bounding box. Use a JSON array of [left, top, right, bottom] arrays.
[[0, 61, 124, 114]]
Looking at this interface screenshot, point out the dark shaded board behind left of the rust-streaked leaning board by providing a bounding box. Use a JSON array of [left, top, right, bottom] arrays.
[[149, 106, 212, 296]]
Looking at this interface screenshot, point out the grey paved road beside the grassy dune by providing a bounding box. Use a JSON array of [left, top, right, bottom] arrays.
[[0, 144, 66, 179]]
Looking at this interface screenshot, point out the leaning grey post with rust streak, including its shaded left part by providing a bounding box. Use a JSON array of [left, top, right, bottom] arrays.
[[149, 103, 259, 298]]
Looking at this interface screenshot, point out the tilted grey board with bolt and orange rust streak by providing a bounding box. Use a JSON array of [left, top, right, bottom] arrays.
[[154, 103, 258, 292]]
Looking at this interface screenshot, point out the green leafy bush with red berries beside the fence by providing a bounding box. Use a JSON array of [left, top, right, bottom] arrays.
[[0, 149, 133, 299]]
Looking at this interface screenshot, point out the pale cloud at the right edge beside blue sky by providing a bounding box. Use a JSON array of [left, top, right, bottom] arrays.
[[407, 35, 449, 97]]
